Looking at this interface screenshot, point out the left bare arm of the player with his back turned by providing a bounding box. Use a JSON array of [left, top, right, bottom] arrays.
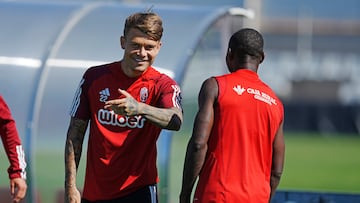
[[180, 78, 218, 203]]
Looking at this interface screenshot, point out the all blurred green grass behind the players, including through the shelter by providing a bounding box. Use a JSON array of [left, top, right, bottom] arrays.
[[0, 132, 360, 203]]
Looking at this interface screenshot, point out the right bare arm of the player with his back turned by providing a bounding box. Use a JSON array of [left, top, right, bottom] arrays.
[[270, 122, 285, 200]]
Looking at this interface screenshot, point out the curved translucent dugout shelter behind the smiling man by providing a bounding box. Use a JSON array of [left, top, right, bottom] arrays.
[[0, 1, 253, 202]]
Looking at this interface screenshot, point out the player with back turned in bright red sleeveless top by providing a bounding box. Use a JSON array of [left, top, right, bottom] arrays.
[[180, 28, 285, 203]]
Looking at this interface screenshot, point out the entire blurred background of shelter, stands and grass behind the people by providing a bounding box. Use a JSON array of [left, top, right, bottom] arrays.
[[0, 0, 360, 202]]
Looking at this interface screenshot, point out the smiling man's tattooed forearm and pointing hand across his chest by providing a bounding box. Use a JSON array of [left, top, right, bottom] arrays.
[[105, 89, 183, 130]]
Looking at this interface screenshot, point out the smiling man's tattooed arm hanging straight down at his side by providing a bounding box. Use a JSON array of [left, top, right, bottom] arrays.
[[65, 117, 88, 203]]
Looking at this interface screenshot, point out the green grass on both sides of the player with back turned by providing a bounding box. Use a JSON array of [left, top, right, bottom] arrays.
[[170, 133, 360, 203]]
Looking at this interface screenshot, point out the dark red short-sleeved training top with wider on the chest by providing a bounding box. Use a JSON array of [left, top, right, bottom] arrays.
[[70, 62, 181, 201]]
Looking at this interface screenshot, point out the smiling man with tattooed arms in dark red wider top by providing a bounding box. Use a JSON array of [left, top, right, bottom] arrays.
[[65, 12, 183, 203]]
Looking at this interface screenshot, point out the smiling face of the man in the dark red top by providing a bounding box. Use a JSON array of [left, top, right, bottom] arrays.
[[120, 28, 161, 77]]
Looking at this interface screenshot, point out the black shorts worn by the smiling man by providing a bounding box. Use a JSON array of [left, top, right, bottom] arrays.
[[81, 185, 158, 203]]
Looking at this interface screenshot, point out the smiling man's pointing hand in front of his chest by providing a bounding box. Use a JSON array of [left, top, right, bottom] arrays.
[[104, 89, 139, 116]]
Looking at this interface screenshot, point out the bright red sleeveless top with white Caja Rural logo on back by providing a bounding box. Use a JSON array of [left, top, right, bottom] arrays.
[[194, 70, 283, 203]]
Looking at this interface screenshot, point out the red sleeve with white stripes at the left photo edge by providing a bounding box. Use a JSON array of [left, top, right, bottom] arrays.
[[0, 96, 26, 179]]
